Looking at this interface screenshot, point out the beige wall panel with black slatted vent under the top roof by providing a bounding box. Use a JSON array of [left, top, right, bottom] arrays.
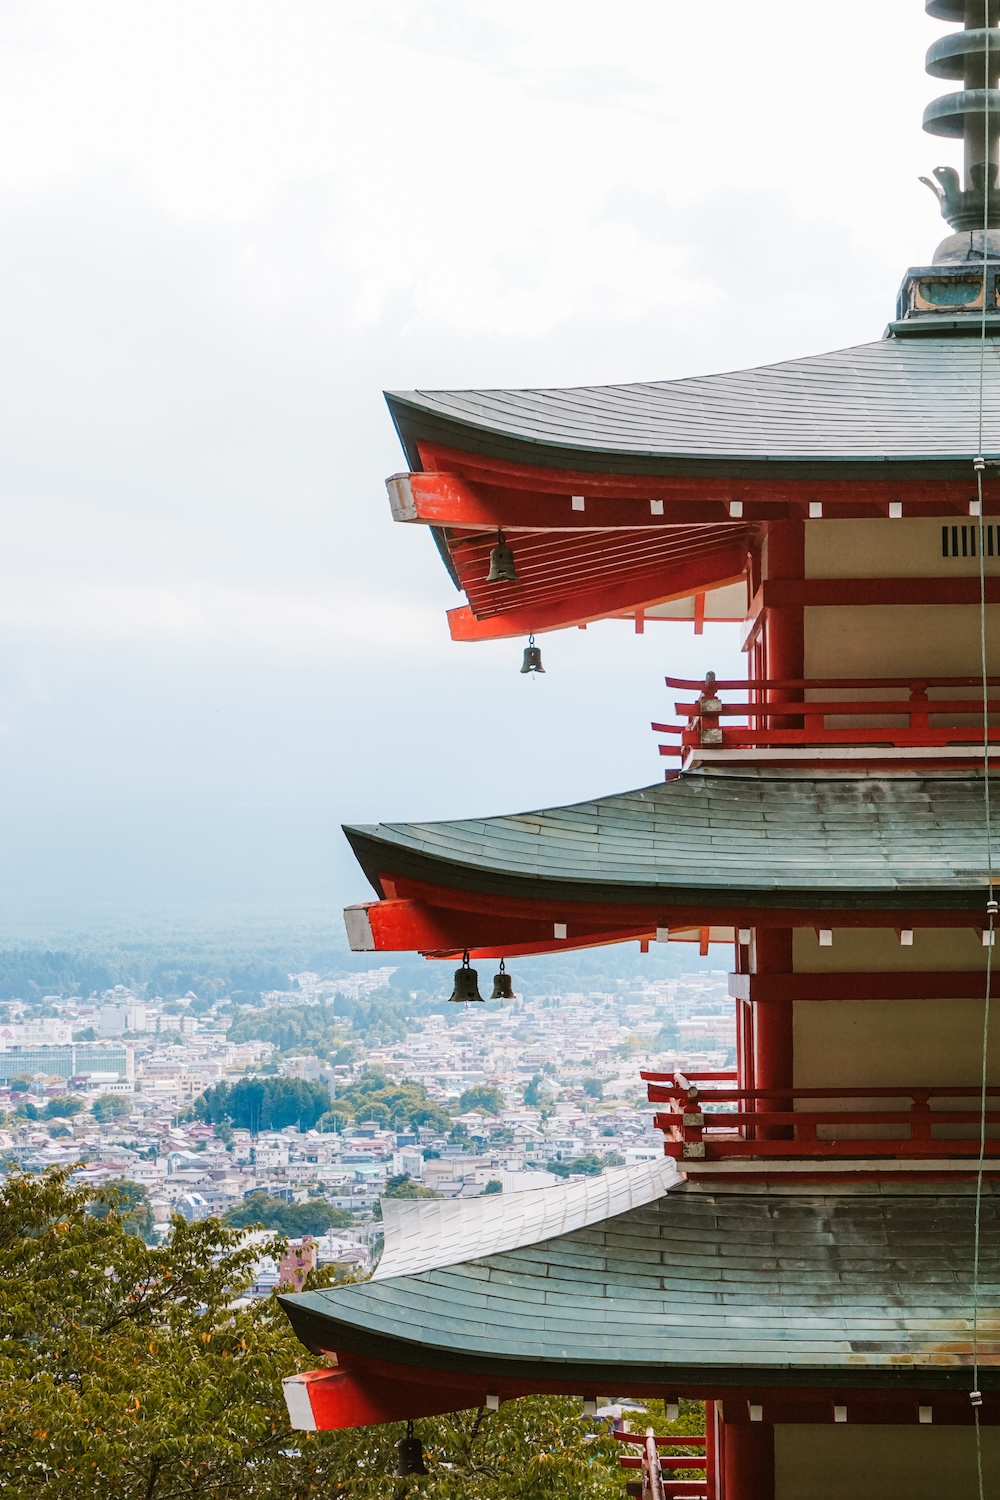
[[805, 516, 1000, 578]]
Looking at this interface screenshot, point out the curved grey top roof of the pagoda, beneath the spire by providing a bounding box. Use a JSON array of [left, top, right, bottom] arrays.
[[387, 336, 1000, 479]]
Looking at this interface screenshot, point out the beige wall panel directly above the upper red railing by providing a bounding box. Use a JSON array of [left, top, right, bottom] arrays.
[[805, 605, 1000, 678]]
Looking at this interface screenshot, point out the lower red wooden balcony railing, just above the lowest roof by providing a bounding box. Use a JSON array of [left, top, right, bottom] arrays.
[[642, 1073, 1000, 1161]]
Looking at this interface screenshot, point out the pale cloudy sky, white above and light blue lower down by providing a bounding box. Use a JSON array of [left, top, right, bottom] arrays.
[[0, 0, 960, 936]]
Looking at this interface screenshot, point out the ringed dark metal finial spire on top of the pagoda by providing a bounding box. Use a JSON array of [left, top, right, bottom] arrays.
[[921, 0, 1000, 231]]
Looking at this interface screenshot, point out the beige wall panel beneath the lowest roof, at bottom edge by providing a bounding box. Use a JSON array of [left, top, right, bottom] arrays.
[[774, 1422, 1000, 1500]]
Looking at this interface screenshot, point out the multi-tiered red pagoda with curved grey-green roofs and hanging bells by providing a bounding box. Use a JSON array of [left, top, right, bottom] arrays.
[[283, 0, 1000, 1500]]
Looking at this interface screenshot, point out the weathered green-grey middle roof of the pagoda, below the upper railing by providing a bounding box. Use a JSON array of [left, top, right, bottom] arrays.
[[345, 771, 987, 911]]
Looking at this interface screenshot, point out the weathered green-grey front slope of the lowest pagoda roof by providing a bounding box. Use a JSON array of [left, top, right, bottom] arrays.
[[282, 1185, 1000, 1389]]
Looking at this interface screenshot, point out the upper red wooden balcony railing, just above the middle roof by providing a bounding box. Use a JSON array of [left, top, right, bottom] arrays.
[[652, 672, 1000, 756]]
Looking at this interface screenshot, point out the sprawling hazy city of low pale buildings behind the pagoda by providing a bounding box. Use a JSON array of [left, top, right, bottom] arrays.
[[0, 950, 735, 1295]]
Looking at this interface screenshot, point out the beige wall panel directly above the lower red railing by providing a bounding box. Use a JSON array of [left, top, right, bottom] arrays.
[[792, 1001, 1000, 1086]]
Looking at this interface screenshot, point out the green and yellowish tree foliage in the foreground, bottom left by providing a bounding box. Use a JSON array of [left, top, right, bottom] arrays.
[[0, 1170, 680, 1500]]
